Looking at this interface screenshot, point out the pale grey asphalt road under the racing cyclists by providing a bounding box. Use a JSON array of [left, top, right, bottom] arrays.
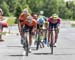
[[0, 27, 75, 60]]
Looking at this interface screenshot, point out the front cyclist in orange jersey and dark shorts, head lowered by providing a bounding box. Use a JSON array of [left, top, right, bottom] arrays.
[[18, 16, 37, 52]]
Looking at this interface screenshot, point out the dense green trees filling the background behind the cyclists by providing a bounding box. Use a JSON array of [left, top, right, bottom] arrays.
[[0, 0, 75, 22]]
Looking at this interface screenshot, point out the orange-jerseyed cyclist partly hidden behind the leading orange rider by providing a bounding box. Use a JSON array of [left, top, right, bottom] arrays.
[[18, 8, 30, 44]]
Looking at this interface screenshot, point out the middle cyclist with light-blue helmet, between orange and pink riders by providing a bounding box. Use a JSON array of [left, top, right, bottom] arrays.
[[35, 15, 45, 47]]
